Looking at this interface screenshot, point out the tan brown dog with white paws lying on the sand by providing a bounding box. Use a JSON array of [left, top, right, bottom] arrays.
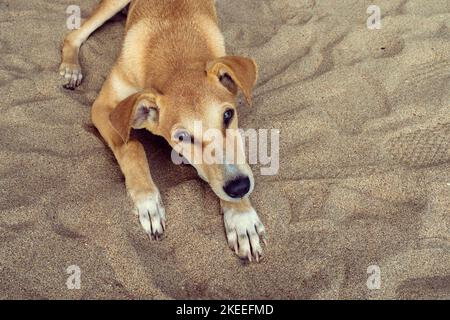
[[60, 0, 264, 261]]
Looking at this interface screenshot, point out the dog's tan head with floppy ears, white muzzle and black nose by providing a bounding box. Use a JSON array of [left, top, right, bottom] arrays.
[[110, 56, 258, 201]]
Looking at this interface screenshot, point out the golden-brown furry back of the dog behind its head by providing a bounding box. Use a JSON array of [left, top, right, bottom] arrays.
[[119, 0, 225, 90]]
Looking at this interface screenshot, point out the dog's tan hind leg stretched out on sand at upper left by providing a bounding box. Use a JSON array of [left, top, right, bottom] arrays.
[[59, 0, 131, 90]]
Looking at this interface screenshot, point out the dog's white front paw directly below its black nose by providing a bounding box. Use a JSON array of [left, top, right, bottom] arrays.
[[223, 208, 266, 262]]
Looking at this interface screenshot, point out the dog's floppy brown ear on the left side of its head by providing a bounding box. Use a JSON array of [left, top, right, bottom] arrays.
[[109, 92, 159, 143]]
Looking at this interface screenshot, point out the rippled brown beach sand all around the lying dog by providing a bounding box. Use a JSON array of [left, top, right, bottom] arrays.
[[0, 0, 450, 299]]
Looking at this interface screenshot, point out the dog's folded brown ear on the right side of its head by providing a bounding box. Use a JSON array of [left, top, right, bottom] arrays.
[[206, 56, 258, 105]]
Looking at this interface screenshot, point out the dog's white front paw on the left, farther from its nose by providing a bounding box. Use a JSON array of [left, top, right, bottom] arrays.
[[135, 192, 166, 240]]
